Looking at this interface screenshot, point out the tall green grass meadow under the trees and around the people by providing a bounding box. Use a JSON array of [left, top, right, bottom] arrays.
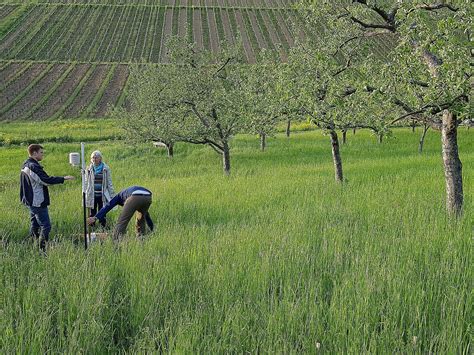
[[0, 124, 474, 354]]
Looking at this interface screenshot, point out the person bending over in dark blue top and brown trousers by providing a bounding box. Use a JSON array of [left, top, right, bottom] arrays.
[[87, 186, 153, 241]]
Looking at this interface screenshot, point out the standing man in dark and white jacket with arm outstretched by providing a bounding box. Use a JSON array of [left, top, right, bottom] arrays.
[[20, 144, 74, 251]]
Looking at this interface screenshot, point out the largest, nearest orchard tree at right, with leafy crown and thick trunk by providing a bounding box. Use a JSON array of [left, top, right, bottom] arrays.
[[302, 0, 473, 215]]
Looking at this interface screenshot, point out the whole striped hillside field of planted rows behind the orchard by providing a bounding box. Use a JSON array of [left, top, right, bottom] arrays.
[[0, 0, 309, 121]]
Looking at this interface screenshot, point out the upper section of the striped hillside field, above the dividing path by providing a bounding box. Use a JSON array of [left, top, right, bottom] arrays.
[[0, 4, 301, 63]]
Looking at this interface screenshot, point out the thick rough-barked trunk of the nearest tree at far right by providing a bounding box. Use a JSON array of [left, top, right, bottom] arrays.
[[441, 110, 463, 216]]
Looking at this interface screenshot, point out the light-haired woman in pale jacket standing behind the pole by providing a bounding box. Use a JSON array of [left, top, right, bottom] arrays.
[[86, 150, 114, 227]]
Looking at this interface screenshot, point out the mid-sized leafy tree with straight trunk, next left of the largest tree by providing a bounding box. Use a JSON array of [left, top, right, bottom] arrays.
[[280, 38, 382, 182]]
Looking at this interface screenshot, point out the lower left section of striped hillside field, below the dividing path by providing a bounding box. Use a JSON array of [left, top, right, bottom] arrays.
[[0, 62, 129, 121]]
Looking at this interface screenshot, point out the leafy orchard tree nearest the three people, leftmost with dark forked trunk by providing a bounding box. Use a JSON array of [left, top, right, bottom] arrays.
[[116, 37, 246, 175]]
